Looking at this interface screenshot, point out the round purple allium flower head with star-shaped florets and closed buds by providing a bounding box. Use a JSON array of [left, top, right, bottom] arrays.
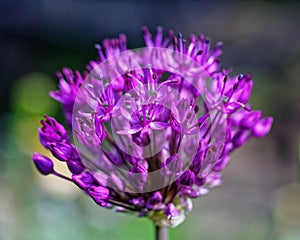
[[33, 28, 273, 227]]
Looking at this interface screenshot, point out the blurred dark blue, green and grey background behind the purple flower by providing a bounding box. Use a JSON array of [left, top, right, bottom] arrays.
[[0, 0, 300, 240]]
